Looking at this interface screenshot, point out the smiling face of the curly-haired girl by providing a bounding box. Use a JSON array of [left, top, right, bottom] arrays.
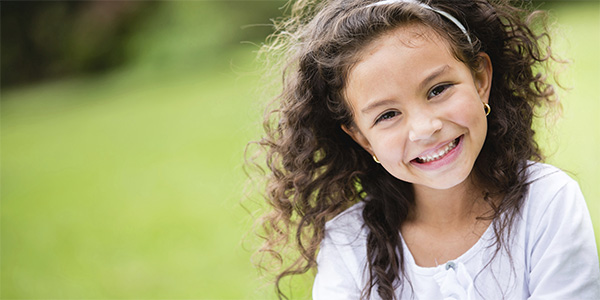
[[343, 25, 492, 189]]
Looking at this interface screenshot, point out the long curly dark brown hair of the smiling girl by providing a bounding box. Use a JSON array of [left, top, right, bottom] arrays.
[[246, 0, 556, 299]]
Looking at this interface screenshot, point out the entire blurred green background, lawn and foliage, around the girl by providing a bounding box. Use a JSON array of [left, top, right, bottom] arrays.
[[0, 1, 600, 299]]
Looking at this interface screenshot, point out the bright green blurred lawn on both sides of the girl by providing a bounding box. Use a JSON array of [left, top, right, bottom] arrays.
[[0, 2, 600, 299]]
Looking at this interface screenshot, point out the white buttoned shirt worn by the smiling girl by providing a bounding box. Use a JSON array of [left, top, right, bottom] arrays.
[[313, 163, 600, 300]]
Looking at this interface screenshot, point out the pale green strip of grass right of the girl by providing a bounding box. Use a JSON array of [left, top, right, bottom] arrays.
[[542, 2, 600, 244]]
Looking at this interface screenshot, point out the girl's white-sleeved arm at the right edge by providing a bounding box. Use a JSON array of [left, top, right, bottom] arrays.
[[529, 175, 600, 300]]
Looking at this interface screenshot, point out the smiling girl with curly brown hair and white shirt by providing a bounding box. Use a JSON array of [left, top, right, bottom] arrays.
[[252, 0, 600, 300]]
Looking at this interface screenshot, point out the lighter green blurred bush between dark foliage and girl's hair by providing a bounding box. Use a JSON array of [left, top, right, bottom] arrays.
[[127, 1, 285, 70]]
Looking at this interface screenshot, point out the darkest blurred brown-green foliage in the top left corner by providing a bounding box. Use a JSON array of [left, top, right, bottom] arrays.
[[0, 0, 156, 87]]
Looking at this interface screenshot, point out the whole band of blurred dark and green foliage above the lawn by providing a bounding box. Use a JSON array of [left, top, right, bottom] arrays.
[[0, 0, 285, 88]]
